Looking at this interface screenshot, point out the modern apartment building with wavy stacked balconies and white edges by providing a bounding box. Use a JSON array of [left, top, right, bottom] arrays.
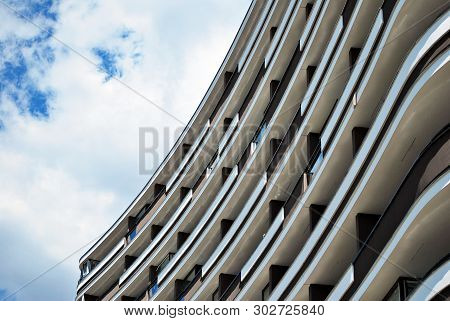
[[76, 0, 450, 301]]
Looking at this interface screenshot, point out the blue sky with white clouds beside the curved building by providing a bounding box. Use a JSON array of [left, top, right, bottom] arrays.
[[0, 0, 250, 300]]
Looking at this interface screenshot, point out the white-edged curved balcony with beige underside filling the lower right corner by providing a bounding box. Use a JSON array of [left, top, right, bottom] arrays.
[[351, 170, 450, 300]]
